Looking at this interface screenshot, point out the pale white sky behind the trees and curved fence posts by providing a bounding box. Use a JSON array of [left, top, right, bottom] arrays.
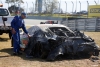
[[1, 0, 100, 12]]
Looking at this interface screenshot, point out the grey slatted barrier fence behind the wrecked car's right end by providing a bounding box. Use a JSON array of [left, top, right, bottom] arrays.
[[61, 18, 100, 31]]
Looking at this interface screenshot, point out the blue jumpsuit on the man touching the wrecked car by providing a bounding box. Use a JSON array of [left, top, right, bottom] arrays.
[[11, 16, 28, 53]]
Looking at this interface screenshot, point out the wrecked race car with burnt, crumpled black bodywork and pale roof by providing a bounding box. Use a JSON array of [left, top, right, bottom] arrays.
[[18, 24, 100, 60]]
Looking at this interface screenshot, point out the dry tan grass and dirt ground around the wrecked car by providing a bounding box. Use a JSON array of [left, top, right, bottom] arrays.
[[0, 32, 100, 67]]
